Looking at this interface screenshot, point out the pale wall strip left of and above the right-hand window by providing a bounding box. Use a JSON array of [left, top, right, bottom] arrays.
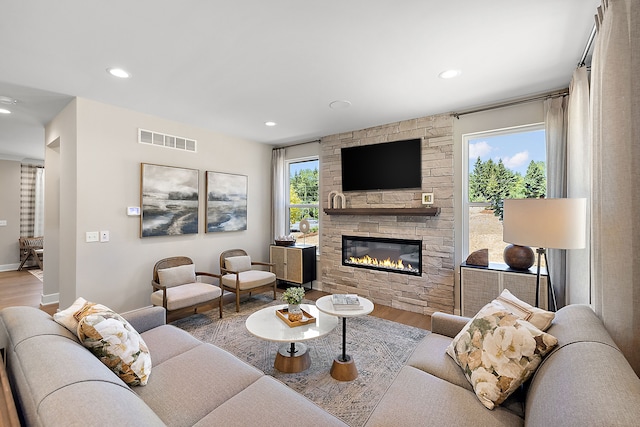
[[453, 101, 544, 314]]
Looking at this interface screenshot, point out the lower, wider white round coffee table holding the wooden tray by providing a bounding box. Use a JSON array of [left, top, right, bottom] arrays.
[[245, 304, 338, 373]]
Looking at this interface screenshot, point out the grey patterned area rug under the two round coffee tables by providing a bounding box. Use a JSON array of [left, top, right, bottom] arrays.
[[172, 295, 429, 427]]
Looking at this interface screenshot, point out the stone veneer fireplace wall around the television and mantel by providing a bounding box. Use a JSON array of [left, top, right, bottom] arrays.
[[320, 114, 454, 314]]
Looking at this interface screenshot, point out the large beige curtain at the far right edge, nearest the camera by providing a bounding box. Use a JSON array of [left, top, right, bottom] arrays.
[[591, 0, 640, 375]]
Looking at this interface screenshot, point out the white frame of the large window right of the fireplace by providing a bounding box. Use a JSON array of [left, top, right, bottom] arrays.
[[462, 122, 548, 258]]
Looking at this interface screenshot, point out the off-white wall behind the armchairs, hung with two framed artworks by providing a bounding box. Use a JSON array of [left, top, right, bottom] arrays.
[[43, 98, 272, 311]]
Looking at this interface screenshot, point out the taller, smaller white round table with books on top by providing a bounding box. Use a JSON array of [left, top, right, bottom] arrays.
[[316, 295, 373, 381]]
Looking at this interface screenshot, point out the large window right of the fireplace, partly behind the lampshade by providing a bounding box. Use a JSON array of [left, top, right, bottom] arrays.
[[463, 124, 547, 263]]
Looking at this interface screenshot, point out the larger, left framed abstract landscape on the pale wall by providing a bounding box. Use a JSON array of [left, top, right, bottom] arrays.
[[140, 163, 199, 237]]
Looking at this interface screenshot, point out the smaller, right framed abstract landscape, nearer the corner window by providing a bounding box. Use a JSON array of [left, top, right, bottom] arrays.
[[206, 171, 247, 233]]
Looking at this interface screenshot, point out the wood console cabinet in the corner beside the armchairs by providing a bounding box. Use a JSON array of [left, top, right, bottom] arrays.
[[269, 245, 316, 289]]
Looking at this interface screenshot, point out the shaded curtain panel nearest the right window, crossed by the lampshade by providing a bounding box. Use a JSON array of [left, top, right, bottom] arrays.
[[544, 96, 568, 308]]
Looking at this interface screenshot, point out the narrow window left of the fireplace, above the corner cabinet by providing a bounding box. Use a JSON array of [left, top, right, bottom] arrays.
[[287, 157, 320, 248]]
